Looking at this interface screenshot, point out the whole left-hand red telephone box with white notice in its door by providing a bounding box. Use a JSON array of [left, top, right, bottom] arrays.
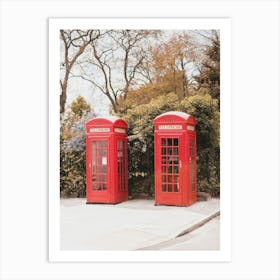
[[86, 117, 128, 203]]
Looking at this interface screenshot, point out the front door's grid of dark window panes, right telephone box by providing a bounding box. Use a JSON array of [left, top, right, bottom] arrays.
[[160, 138, 179, 192]]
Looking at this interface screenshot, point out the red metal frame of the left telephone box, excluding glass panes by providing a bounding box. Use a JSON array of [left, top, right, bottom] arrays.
[[86, 117, 128, 204]]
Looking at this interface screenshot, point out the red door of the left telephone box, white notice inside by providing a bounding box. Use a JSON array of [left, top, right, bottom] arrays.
[[87, 138, 109, 202]]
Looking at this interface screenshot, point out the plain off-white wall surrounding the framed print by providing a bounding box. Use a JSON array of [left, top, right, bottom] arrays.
[[0, 0, 280, 279]]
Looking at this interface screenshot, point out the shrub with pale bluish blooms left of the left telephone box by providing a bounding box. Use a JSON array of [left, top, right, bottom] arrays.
[[60, 96, 94, 197]]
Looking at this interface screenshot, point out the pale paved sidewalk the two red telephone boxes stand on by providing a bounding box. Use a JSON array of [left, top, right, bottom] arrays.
[[60, 198, 220, 250]]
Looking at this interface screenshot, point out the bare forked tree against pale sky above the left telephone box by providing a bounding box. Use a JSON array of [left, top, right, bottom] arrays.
[[76, 30, 158, 113]]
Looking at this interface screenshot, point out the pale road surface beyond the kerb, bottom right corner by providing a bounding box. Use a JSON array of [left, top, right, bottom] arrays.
[[141, 216, 220, 250]]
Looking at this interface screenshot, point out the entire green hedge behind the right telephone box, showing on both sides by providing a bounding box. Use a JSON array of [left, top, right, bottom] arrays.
[[121, 93, 220, 196]]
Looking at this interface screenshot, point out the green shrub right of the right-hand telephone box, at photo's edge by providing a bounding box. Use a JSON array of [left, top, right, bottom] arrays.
[[180, 94, 220, 196]]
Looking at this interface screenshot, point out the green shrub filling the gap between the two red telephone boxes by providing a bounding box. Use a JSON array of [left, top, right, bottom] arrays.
[[121, 93, 179, 195]]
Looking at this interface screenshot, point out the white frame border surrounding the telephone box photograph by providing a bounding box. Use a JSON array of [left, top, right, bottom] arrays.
[[49, 18, 231, 262]]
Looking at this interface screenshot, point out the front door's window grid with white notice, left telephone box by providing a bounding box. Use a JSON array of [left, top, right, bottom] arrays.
[[92, 140, 108, 191]]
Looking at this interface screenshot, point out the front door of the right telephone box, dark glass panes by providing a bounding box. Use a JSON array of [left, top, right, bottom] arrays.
[[157, 135, 184, 205]]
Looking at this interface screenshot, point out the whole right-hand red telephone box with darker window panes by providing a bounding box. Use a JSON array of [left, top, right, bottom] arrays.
[[154, 111, 197, 206]]
